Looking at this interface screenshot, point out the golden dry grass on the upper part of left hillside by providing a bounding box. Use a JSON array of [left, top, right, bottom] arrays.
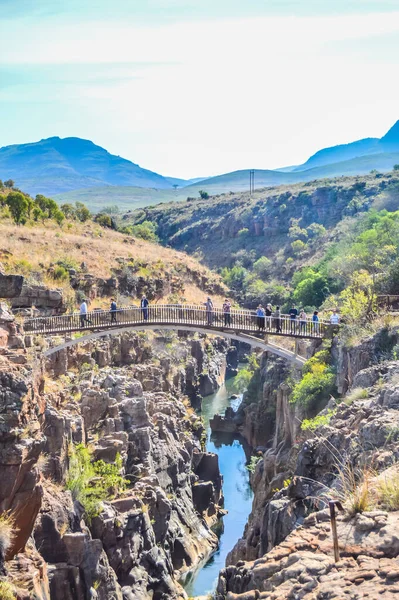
[[0, 219, 227, 303]]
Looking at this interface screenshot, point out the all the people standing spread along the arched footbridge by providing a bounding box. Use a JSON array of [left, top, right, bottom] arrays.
[[80, 294, 340, 335]]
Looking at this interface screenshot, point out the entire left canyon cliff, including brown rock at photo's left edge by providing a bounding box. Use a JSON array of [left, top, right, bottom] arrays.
[[0, 320, 228, 600]]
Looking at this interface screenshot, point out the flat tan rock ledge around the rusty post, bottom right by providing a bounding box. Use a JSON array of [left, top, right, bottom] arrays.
[[216, 511, 399, 600]]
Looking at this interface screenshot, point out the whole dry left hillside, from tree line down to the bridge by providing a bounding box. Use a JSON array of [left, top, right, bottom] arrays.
[[0, 189, 226, 310]]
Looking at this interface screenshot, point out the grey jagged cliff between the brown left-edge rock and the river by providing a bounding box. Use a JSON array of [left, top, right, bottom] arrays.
[[18, 333, 227, 600]]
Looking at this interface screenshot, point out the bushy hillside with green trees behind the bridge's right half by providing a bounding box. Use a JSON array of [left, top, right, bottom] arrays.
[[124, 171, 399, 332]]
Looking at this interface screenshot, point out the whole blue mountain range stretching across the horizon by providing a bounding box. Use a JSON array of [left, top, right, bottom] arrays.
[[0, 121, 399, 210]]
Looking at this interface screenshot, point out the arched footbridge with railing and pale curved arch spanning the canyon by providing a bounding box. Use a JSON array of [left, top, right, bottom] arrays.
[[23, 304, 331, 366]]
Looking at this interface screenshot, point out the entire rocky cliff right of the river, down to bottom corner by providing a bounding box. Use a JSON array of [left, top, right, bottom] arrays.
[[217, 328, 399, 600]]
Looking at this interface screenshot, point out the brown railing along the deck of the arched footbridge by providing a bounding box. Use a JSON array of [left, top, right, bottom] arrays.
[[24, 304, 329, 338]]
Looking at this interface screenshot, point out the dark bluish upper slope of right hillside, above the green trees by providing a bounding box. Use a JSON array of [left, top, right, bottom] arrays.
[[126, 172, 399, 279]]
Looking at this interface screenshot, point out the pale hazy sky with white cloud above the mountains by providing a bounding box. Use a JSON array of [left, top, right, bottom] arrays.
[[0, 0, 399, 177]]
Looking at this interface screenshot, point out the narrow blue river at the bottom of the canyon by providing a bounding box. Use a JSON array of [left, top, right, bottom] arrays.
[[185, 380, 252, 596]]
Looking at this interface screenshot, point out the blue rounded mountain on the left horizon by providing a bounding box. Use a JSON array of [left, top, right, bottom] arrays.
[[0, 137, 191, 195]]
